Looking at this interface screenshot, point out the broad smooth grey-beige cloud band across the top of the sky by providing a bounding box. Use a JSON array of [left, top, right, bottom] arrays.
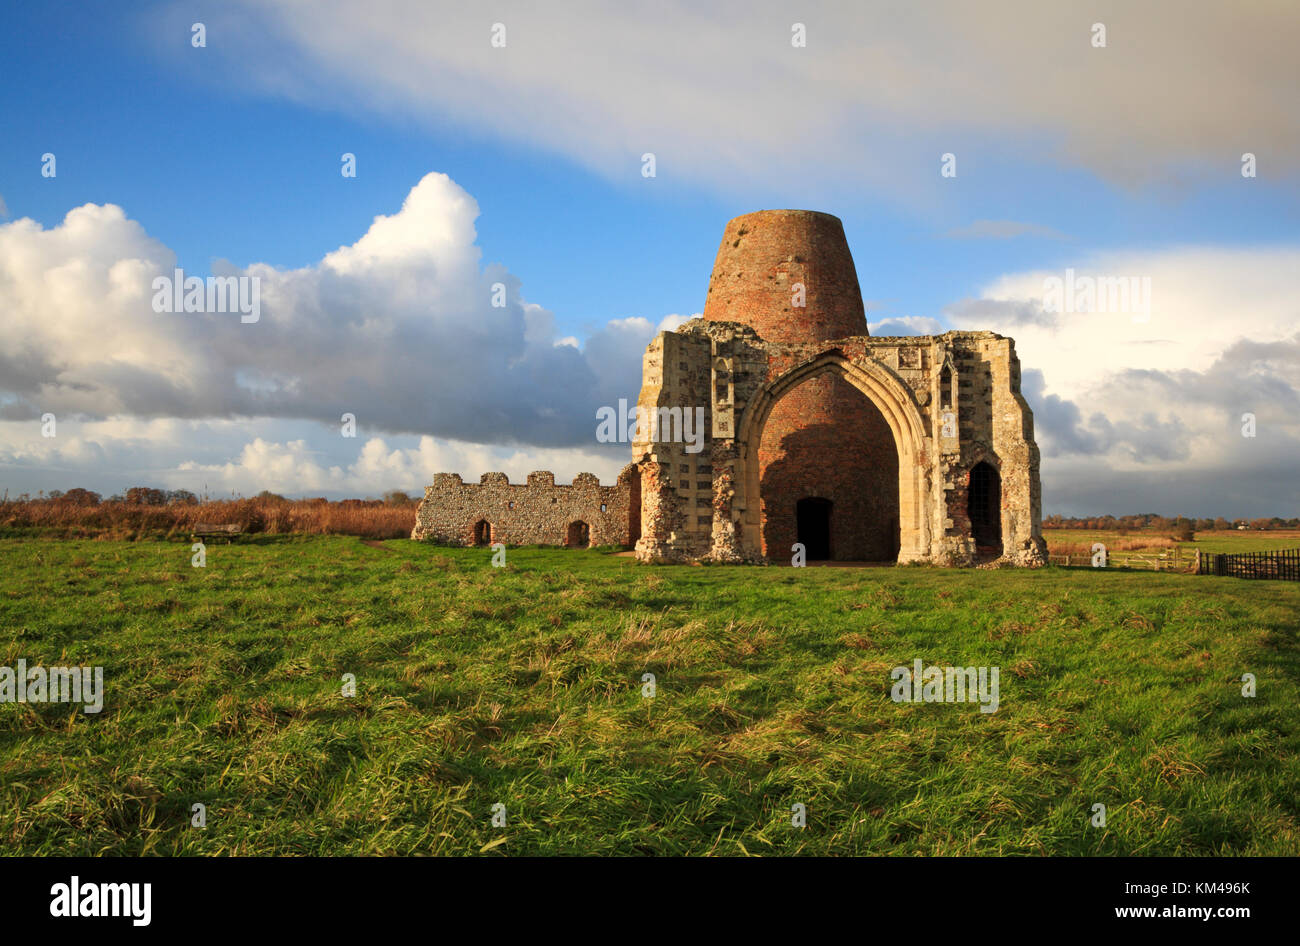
[[180, 0, 1300, 201]]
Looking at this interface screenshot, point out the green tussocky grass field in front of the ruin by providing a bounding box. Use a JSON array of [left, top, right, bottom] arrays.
[[0, 537, 1300, 855]]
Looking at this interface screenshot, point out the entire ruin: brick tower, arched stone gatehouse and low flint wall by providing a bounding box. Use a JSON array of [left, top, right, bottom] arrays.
[[412, 211, 1045, 565]]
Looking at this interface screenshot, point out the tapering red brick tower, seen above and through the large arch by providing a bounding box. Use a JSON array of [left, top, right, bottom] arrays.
[[703, 211, 898, 561]]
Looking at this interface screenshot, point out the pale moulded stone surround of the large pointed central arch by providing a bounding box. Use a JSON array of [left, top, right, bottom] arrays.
[[735, 351, 932, 563]]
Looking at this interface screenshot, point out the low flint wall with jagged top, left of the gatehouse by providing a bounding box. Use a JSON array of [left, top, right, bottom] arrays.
[[411, 464, 640, 546]]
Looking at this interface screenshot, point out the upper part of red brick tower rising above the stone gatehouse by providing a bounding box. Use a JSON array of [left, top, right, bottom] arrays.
[[705, 211, 867, 342]]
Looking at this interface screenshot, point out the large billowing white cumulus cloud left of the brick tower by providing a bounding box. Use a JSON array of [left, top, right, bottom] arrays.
[[0, 174, 676, 447]]
